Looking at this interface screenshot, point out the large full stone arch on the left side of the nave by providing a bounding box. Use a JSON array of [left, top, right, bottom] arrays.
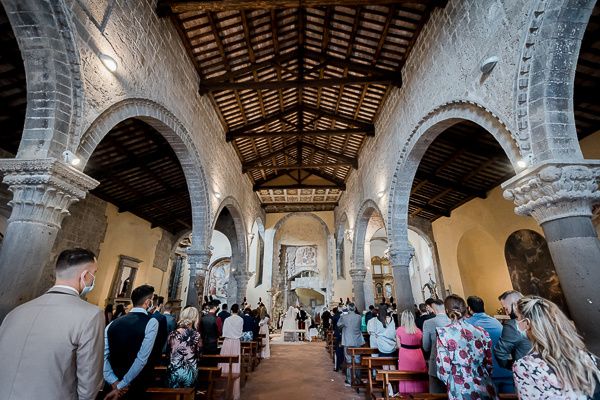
[[75, 98, 211, 249]]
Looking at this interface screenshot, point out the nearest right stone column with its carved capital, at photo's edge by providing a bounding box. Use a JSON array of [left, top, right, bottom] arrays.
[[502, 160, 600, 354]]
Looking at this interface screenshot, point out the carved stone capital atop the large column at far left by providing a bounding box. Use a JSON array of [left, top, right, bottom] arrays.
[[0, 158, 100, 229]]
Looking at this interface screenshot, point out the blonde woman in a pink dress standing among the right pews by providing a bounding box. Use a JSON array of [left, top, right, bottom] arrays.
[[396, 310, 429, 393]]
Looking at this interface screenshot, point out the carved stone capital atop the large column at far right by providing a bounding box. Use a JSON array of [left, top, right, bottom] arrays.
[[502, 160, 600, 225]]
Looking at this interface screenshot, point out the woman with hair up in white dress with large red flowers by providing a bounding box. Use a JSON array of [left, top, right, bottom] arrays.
[[436, 294, 498, 400]]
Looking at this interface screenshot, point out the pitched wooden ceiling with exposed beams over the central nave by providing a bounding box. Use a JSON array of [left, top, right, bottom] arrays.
[[157, 0, 444, 210]]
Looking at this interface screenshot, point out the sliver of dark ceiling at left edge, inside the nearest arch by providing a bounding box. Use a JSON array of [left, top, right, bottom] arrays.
[[0, 5, 27, 154]]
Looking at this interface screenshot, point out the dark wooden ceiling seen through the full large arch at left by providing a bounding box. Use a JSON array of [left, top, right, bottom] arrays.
[[85, 118, 192, 233]]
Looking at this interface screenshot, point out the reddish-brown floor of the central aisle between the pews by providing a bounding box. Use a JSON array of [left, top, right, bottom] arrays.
[[241, 342, 365, 400]]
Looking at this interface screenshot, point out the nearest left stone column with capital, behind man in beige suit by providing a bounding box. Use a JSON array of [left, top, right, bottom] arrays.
[[0, 158, 99, 320]]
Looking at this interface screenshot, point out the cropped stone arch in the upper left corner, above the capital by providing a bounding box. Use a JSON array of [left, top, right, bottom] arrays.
[[0, 0, 83, 159]]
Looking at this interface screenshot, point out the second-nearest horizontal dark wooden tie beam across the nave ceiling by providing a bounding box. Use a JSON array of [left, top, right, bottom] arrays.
[[199, 73, 401, 95]]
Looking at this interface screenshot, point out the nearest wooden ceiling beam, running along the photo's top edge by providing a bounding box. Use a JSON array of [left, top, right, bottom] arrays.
[[157, 0, 445, 16]]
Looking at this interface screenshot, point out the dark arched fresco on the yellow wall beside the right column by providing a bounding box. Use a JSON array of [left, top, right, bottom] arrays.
[[504, 229, 568, 313]]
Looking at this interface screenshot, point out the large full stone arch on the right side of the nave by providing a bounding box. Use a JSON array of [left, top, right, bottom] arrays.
[[387, 100, 522, 255]]
